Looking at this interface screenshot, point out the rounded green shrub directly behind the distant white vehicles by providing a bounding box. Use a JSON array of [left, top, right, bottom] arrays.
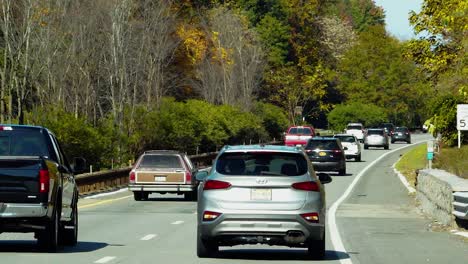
[[327, 102, 387, 131]]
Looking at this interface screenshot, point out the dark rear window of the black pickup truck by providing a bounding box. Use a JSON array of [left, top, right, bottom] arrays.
[[0, 129, 49, 157]]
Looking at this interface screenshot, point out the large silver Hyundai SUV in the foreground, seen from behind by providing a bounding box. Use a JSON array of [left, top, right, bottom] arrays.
[[197, 145, 331, 259]]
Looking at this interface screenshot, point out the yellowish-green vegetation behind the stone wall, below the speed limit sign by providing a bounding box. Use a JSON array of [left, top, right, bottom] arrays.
[[434, 145, 468, 179]]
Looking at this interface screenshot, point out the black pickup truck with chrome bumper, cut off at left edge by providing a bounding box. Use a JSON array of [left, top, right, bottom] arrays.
[[0, 125, 85, 252]]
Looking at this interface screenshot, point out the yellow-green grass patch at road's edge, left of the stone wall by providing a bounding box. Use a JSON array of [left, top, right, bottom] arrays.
[[395, 144, 427, 186]]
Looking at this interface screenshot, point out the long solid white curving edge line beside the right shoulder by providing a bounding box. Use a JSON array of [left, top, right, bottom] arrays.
[[328, 140, 427, 264]]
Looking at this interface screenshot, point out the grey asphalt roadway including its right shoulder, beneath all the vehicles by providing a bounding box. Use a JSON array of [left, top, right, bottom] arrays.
[[0, 135, 468, 264]]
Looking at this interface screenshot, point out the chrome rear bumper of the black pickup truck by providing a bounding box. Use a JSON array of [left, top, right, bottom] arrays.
[[0, 203, 47, 218]]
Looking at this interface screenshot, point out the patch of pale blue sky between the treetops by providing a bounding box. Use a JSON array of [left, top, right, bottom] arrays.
[[374, 0, 423, 40]]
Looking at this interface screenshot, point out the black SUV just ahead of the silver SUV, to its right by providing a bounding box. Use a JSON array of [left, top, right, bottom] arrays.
[[305, 137, 347, 175]]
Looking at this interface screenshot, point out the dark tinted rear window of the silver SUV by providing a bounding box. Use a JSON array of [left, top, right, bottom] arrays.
[[216, 152, 308, 176]]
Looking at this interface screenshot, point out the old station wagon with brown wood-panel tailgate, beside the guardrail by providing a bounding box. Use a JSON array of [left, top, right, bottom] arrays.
[[128, 150, 198, 201]]
